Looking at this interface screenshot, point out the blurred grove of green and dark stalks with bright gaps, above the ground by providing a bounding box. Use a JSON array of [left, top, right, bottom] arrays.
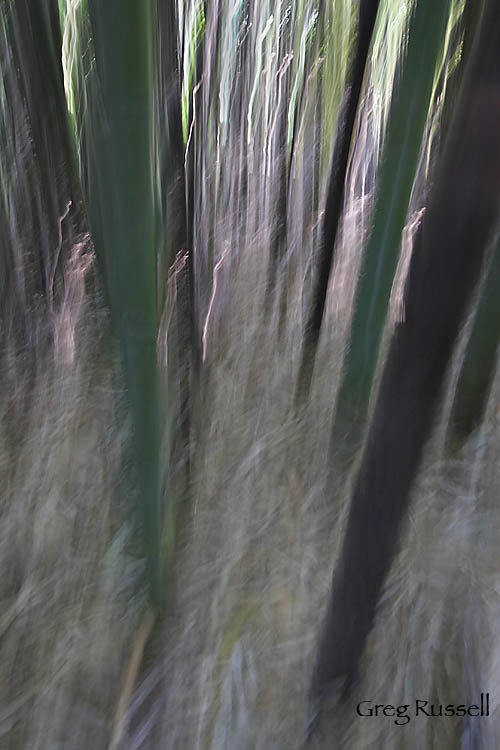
[[0, 0, 500, 748]]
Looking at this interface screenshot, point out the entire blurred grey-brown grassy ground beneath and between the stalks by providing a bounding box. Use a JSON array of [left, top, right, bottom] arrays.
[[0, 248, 500, 750]]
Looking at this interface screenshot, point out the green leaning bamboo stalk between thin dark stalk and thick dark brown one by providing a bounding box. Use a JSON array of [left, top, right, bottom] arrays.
[[331, 0, 450, 455]]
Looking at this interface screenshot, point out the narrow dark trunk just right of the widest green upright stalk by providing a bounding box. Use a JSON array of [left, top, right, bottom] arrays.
[[157, 1, 203, 503]]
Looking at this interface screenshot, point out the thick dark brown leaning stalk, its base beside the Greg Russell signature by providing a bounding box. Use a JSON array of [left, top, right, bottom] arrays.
[[311, 0, 500, 712]]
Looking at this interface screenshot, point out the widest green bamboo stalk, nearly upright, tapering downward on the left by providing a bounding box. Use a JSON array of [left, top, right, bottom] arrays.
[[89, 0, 163, 610]]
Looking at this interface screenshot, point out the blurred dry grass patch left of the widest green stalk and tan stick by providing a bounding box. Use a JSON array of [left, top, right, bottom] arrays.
[[0, 258, 143, 749]]
